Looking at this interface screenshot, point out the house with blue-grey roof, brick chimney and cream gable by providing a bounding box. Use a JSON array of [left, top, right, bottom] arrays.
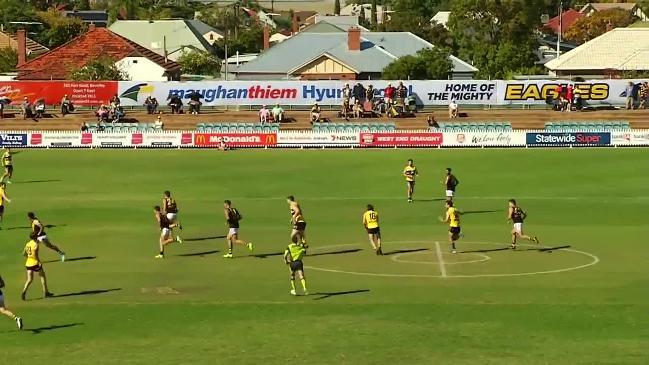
[[231, 27, 478, 80]]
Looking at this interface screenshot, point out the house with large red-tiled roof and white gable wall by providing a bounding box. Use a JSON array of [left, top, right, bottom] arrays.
[[16, 25, 180, 81]]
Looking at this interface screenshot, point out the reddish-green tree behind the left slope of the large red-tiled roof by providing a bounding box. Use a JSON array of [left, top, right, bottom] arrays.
[[38, 9, 88, 48]]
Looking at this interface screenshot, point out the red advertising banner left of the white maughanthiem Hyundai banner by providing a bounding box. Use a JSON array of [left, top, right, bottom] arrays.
[[0, 81, 118, 105]]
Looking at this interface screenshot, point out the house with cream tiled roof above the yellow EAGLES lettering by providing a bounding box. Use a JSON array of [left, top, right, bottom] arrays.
[[545, 28, 649, 77]]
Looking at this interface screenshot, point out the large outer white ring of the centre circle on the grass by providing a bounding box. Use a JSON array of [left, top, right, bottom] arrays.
[[305, 241, 600, 278]]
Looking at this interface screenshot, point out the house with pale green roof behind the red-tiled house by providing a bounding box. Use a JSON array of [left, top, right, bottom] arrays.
[[109, 19, 214, 61]]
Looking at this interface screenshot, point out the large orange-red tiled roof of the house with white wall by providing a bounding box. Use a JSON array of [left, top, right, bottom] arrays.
[[18, 28, 180, 80]]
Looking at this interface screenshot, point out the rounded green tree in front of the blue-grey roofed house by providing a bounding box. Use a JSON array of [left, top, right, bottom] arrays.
[[383, 48, 453, 80]]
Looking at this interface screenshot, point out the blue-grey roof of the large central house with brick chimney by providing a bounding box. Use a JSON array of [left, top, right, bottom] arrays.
[[233, 31, 478, 74]]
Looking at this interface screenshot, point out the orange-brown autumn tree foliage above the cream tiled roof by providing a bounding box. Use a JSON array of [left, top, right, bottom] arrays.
[[563, 9, 638, 44]]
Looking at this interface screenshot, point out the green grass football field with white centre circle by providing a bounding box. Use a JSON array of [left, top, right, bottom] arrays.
[[0, 149, 649, 365]]
